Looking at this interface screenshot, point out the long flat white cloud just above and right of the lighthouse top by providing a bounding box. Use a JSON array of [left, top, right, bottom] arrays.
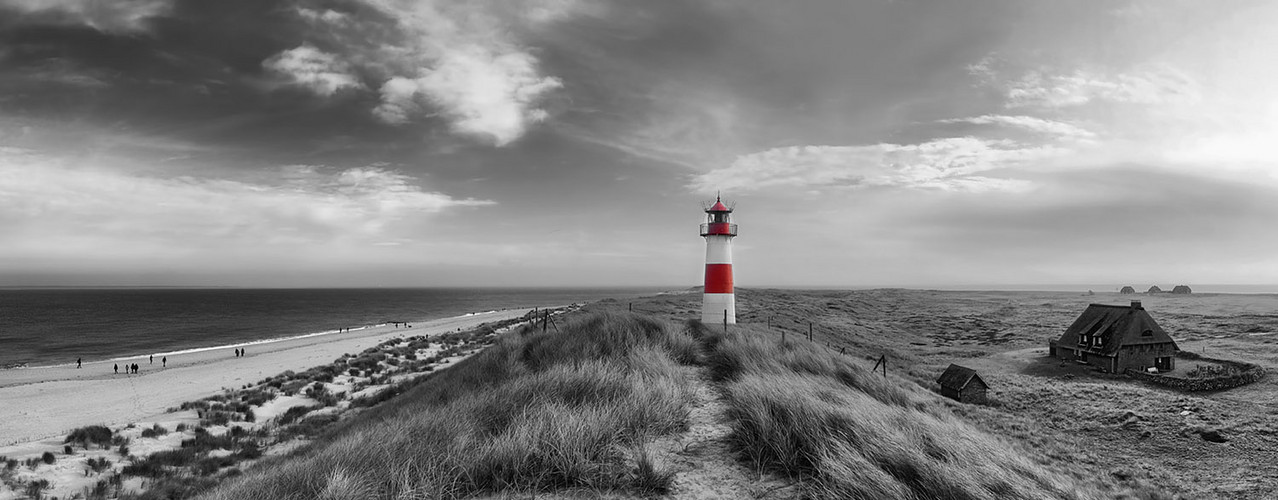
[[690, 137, 1065, 192]]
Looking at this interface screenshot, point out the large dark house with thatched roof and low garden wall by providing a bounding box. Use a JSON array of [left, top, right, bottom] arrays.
[[1048, 301, 1180, 373]]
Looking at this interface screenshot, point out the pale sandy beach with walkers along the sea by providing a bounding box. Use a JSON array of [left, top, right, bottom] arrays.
[[0, 308, 530, 446]]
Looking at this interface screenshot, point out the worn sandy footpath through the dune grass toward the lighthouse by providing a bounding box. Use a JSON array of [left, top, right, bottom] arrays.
[[651, 367, 795, 499]]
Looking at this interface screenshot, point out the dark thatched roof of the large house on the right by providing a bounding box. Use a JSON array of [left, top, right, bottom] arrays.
[[1057, 302, 1180, 355]]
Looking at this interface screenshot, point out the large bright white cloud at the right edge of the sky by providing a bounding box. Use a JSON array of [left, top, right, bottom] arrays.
[[961, 47, 1278, 182]]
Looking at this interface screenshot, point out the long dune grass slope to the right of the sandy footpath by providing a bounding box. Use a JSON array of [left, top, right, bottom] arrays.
[[690, 322, 1134, 500]]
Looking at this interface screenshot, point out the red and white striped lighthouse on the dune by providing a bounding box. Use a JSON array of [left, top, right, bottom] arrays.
[[702, 196, 736, 325]]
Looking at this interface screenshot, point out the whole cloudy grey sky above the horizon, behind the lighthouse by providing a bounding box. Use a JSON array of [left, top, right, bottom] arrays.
[[0, 0, 1278, 289]]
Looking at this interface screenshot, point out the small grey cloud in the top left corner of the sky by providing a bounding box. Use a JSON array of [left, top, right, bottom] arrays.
[[0, 0, 171, 33]]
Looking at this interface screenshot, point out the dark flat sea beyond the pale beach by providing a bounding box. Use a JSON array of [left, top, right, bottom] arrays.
[[0, 288, 663, 368]]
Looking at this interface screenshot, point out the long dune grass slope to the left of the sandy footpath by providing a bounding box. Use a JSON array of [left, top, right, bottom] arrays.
[[206, 313, 697, 500]]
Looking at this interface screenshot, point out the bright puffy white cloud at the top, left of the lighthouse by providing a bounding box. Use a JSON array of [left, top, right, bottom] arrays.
[[290, 0, 578, 146]]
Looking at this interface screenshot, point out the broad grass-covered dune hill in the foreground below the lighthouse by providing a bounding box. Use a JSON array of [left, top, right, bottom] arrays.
[[194, 304, 1154, 500]]
